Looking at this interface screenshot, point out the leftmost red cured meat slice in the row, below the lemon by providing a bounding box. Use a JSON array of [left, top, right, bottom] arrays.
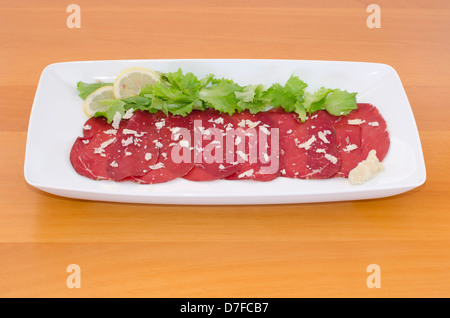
[[70, 117, 125, 180]]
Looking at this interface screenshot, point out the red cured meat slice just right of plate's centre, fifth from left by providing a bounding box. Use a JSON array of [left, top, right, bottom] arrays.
[[226, 111, 283, 181]]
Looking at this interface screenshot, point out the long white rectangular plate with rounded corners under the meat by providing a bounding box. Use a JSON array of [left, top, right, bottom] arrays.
[[25, 59, 426, 204]]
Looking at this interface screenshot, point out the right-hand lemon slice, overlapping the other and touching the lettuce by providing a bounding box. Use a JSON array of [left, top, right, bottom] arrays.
[[114, 67, 159, 99]]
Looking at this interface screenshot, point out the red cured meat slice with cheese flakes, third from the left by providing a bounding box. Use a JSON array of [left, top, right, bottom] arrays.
[[131, 116, 194, 184]]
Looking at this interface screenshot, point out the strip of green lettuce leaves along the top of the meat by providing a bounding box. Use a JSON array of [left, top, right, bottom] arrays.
[[77, 69, 357, 123]]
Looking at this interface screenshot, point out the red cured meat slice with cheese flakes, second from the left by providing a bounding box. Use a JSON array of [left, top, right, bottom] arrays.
[[106, 110, 160, 181]]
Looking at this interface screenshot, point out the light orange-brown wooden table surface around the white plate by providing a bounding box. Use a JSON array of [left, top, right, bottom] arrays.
[[0, 0, 450, 297]]
